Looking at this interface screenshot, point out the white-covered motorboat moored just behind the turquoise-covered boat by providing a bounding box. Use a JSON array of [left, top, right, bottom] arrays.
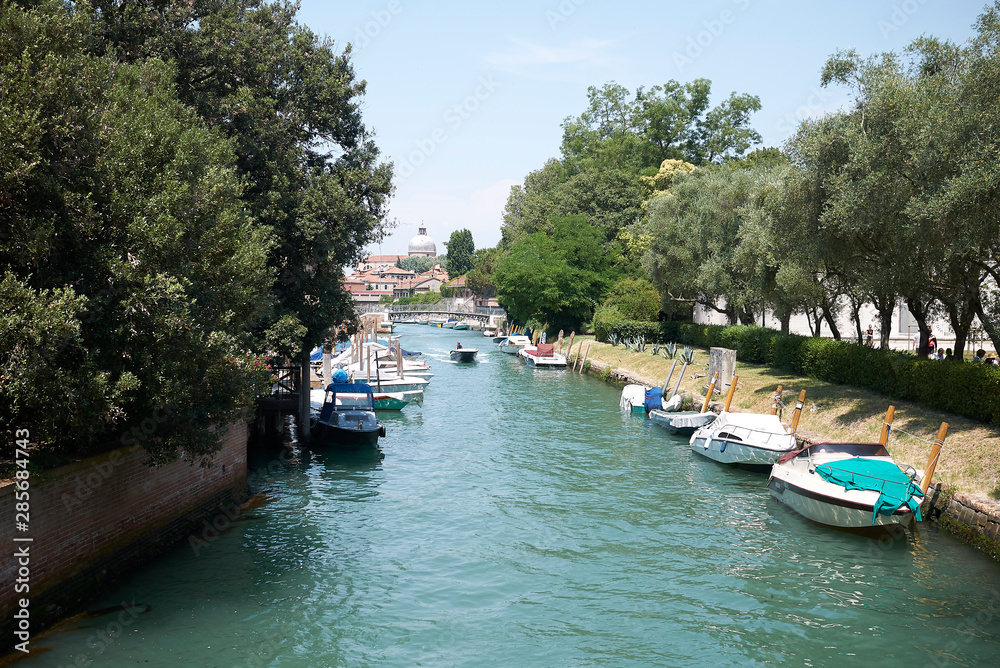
[[690, 412, 796, 472]]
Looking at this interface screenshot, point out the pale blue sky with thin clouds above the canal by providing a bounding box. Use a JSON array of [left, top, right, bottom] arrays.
[[297, 0, 986, 254]]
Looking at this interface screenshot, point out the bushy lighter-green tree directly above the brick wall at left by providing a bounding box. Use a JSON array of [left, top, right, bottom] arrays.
[[0, 1, 271, 462]]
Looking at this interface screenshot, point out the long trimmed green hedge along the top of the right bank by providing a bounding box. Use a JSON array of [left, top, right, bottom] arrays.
[[594, 318, 1000, 425]]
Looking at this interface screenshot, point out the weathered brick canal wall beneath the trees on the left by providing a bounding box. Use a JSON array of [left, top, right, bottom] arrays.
[[0, 421, 247, 637]]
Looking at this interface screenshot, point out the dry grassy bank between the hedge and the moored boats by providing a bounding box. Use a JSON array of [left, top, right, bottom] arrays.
[[574, 337, 1000, 499]]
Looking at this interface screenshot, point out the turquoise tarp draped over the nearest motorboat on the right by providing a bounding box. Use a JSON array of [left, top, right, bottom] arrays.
[[816, 457, 924, 524]]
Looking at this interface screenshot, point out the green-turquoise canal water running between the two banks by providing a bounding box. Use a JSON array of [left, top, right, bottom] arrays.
[[18, 325, 1000, 668]]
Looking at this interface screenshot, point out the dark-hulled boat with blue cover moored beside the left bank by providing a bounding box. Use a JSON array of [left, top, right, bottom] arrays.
[[311, 383, 385, 450]]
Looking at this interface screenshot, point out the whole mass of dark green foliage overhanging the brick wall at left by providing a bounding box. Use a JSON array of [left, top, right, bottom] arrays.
[[0, 0, 391, 462]]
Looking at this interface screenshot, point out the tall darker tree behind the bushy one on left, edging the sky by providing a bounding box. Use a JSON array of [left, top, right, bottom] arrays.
[[89, 0, 392, 353]]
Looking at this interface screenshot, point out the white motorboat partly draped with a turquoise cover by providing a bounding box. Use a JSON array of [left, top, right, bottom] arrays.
[[767, 443, 923, 529]]
